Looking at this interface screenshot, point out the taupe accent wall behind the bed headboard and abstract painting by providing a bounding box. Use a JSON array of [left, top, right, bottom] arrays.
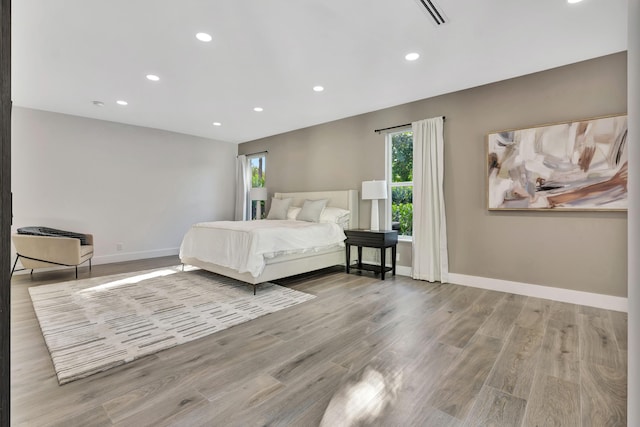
[[238, 52, 627, 297]]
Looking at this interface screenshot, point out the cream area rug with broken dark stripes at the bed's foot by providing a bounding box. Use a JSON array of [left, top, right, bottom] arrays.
[[29, 266, 314, 385]]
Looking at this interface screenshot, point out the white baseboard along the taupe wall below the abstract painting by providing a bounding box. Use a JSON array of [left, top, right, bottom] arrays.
[[449, 273, 628, 313]]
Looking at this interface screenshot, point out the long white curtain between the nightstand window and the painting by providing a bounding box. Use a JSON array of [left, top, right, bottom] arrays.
[[411, 117, 449, 283]]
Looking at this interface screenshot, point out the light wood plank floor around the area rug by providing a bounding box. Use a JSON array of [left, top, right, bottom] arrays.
[[11, 257, 627, 427]]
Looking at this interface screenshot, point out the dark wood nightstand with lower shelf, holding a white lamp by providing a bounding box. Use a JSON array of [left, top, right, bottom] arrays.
[[344, 230, 398, 280]]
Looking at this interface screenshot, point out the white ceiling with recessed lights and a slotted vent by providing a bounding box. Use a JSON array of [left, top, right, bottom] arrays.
[[12, 0, 627, 143]]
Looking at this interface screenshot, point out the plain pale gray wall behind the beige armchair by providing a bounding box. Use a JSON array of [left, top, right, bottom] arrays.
[[11, 107, 237, 264]]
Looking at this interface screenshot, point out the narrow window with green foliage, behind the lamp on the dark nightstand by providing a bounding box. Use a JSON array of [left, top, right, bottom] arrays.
[[387, 129, 413, 238]]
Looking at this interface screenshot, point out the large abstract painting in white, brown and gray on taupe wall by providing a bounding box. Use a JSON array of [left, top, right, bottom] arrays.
[[487, 115, 627, 210]]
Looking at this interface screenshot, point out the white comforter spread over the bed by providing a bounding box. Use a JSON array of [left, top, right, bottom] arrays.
[[180, 220, 346, 277]]
